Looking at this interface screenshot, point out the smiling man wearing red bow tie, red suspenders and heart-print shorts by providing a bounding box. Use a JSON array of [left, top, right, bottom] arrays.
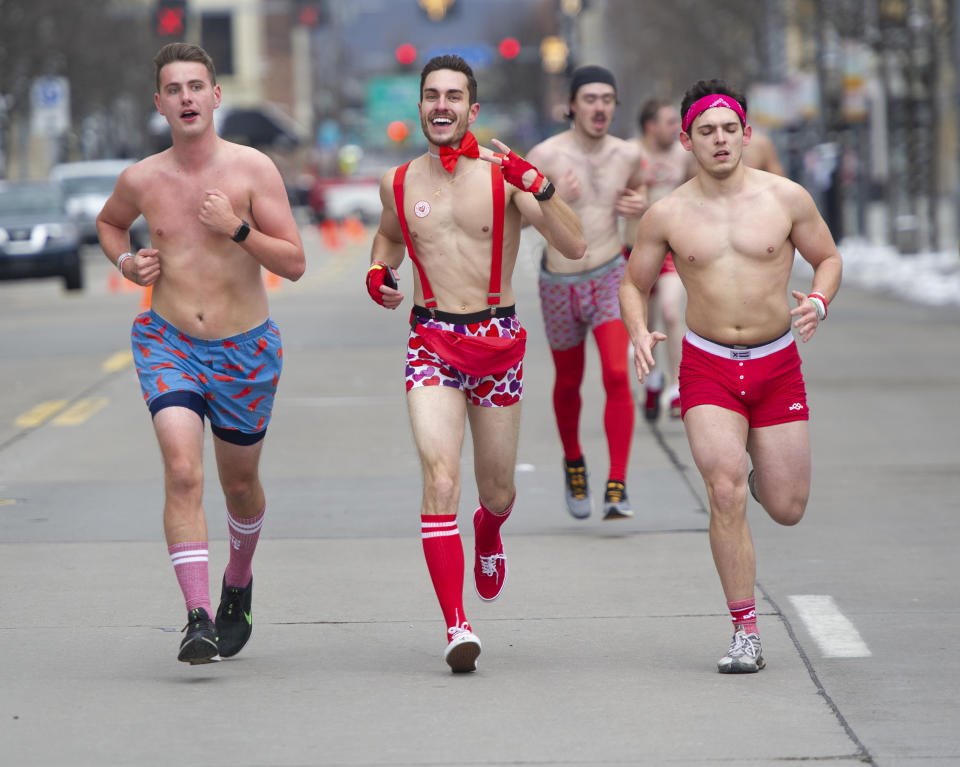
[[367, 55, 586, 672]]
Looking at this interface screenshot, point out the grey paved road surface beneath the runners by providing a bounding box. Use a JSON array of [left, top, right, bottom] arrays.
[[0, 231, 960, 767]]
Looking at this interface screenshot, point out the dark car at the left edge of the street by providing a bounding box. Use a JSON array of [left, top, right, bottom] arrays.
[[0, 181, 83, 290]]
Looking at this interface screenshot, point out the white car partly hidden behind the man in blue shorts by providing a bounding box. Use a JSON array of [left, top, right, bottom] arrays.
[[50, 159, 150, 250]]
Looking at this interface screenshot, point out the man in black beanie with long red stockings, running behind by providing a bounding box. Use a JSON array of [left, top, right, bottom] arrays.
[[528, 65, 646, 519]]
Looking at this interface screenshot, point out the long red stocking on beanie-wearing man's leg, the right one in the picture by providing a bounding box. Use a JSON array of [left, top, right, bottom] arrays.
[[593, 320, 634, 482]]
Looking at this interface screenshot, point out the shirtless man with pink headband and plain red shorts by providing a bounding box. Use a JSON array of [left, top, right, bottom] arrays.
[[620, 80, 842, 674]]
